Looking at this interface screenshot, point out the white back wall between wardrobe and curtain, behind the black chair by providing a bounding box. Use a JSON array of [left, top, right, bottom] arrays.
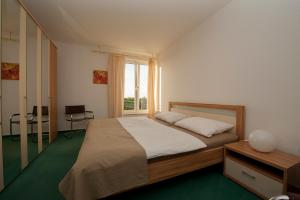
[[56, 42, 107, 130]]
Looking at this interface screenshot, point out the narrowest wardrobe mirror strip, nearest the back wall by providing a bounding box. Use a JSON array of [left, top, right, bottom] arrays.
[[42, 34, 50, 149]]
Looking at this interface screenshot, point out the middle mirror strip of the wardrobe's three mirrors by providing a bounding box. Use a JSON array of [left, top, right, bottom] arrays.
[[26, 15, 38, 162]]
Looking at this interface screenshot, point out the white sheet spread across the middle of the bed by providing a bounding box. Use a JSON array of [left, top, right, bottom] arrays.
[[118, 117, 206, 159]]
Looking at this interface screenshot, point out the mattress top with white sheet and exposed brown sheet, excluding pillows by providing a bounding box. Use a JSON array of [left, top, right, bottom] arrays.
[[118, 116, 238, 161]]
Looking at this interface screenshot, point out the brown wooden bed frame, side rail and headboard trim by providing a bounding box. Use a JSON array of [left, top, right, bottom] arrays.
[[148, 102, 245, 184]]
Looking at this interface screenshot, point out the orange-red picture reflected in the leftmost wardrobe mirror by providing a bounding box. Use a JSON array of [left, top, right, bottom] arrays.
[[1, 63, 20, 80]]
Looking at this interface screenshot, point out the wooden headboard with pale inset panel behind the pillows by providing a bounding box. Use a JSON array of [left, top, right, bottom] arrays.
[[169, 102, 245, 140]]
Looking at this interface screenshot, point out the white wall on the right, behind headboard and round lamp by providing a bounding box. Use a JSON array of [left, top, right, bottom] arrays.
[[160, 0, 300, 155]]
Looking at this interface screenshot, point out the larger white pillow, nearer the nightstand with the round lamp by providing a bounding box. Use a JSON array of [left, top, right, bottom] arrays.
[[175, 117, 234, 137]]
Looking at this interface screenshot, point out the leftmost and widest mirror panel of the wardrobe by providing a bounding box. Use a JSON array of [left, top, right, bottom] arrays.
[[1, 0, 21, 185]]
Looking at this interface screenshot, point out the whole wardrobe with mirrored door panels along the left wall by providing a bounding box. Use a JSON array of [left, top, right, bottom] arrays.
[[0, 0, 57, 190]]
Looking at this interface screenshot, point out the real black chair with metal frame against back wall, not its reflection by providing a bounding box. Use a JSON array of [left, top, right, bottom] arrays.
[[64, 105, 94, 137]]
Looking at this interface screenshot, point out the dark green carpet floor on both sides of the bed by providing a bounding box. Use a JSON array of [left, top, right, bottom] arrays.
[[0, 131, 259, 200]]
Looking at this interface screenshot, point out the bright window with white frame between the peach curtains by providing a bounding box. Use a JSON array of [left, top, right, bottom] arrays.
[[124, 60, 148, 113]]
